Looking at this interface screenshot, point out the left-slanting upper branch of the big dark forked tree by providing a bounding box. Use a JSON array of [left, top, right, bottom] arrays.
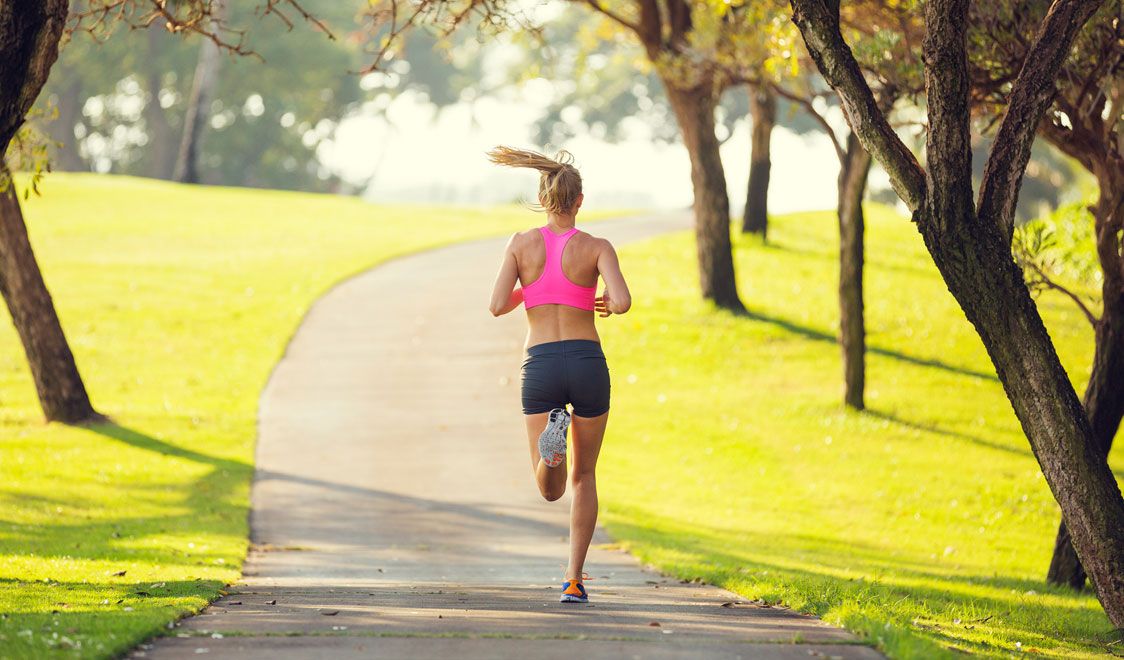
[[789, 0, 926, 211]]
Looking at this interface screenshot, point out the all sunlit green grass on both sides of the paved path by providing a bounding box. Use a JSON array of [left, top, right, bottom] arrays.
[[0, 175, 1122, 658]]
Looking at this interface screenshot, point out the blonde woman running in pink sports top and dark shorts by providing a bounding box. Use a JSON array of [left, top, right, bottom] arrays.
[[488, 146, 632, 603]]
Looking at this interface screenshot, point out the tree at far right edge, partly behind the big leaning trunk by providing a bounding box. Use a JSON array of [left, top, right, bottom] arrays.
[[969, 0, 1124, 589]]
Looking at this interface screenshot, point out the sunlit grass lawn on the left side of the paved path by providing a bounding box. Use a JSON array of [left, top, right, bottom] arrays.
[[0, 174, 624, 658]]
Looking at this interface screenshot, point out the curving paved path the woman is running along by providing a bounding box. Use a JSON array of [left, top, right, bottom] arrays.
[[135, 216, 880, 660]]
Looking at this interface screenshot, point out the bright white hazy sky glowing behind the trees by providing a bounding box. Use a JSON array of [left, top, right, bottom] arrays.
[[323, 81, 885, 214]]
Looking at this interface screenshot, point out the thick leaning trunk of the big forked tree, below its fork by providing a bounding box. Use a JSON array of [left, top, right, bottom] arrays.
[[919, 203, 1124, 627]]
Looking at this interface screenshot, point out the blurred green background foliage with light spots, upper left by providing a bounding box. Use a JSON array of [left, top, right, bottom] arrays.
[[32, 0, 360, 190]]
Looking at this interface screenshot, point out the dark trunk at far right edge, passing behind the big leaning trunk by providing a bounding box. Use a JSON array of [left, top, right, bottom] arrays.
[[1046, 175, 1124, 589]]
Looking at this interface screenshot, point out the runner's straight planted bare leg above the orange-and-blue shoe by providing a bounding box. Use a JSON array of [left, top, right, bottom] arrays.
[[565, 413, 609, 580]]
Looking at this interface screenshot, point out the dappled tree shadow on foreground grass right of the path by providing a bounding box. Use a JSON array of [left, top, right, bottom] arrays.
[[609, 506, 1114, 654]]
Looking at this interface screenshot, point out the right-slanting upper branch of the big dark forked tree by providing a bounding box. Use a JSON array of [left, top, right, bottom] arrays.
[[977, 0, 1104, 242]]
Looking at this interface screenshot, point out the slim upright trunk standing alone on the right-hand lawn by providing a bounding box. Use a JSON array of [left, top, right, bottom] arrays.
[[839, 133, 871, 410]]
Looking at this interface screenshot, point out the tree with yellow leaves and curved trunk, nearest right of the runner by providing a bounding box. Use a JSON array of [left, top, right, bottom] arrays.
[[369, 0, 818, 311]]
